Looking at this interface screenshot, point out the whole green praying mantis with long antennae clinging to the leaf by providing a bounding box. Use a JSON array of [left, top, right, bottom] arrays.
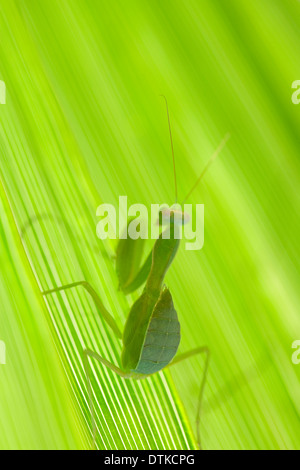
[[27, 97, 230, 449]]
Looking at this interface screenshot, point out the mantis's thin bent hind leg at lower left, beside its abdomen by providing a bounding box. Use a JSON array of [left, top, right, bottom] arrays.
[[82, 349, 132, 449]]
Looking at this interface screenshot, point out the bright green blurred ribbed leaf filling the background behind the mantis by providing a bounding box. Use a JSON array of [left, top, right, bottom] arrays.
[[0, 0, 300, 449]]
